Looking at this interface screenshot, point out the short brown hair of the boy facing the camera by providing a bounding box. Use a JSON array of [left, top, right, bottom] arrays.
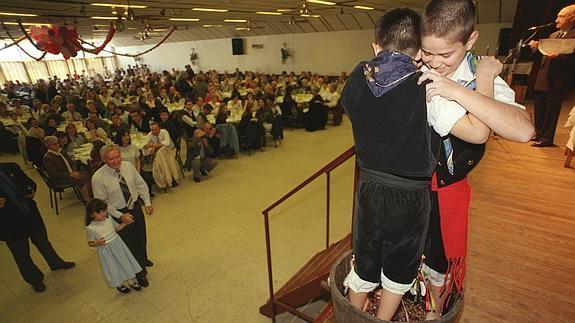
[[421, 0, 476, 44]]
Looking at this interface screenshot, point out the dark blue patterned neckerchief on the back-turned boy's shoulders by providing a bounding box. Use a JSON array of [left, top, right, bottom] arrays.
[[363, 51, 417, 98]]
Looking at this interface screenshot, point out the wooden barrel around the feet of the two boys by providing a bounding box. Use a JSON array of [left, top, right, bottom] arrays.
[[329, 250, 463, 323]]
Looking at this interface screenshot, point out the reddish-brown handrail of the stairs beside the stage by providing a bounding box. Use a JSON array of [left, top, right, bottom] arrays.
[[262, 146, 359, 322]]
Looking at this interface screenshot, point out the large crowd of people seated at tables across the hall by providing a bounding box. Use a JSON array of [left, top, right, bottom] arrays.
[[0, 65, 347, 195]]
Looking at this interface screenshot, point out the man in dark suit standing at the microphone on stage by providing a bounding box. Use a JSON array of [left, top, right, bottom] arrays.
[[529, 4, 575, 147]]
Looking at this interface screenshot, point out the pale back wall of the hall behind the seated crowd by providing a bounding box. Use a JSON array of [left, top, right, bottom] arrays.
[[116, 30, 373, 75]]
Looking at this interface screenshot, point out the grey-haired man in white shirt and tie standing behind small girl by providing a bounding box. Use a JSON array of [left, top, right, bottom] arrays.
[[92, 145, 154, 287]]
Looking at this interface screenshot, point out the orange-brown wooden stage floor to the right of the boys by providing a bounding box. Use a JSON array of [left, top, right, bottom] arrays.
[[460, 98, 575, 322]]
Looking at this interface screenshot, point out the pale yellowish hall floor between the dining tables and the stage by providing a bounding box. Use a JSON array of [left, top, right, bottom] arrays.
[[0, 121, 353, 322]]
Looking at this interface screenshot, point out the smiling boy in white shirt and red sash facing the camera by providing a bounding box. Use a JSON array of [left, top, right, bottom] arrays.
[[414, 0, 534, 319]]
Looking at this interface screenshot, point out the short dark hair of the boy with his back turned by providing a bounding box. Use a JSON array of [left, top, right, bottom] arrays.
[[375, 8, 421, 55]]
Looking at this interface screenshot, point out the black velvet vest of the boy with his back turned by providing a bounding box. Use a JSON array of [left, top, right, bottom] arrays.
[[341, 62, 441, 178]]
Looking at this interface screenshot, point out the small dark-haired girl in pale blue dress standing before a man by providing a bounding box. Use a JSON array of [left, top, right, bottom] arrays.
[[86, 199, 142, 293]]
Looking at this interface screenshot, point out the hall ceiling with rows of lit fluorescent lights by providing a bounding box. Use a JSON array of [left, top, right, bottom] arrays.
[[0, 0, 517, 47]]
